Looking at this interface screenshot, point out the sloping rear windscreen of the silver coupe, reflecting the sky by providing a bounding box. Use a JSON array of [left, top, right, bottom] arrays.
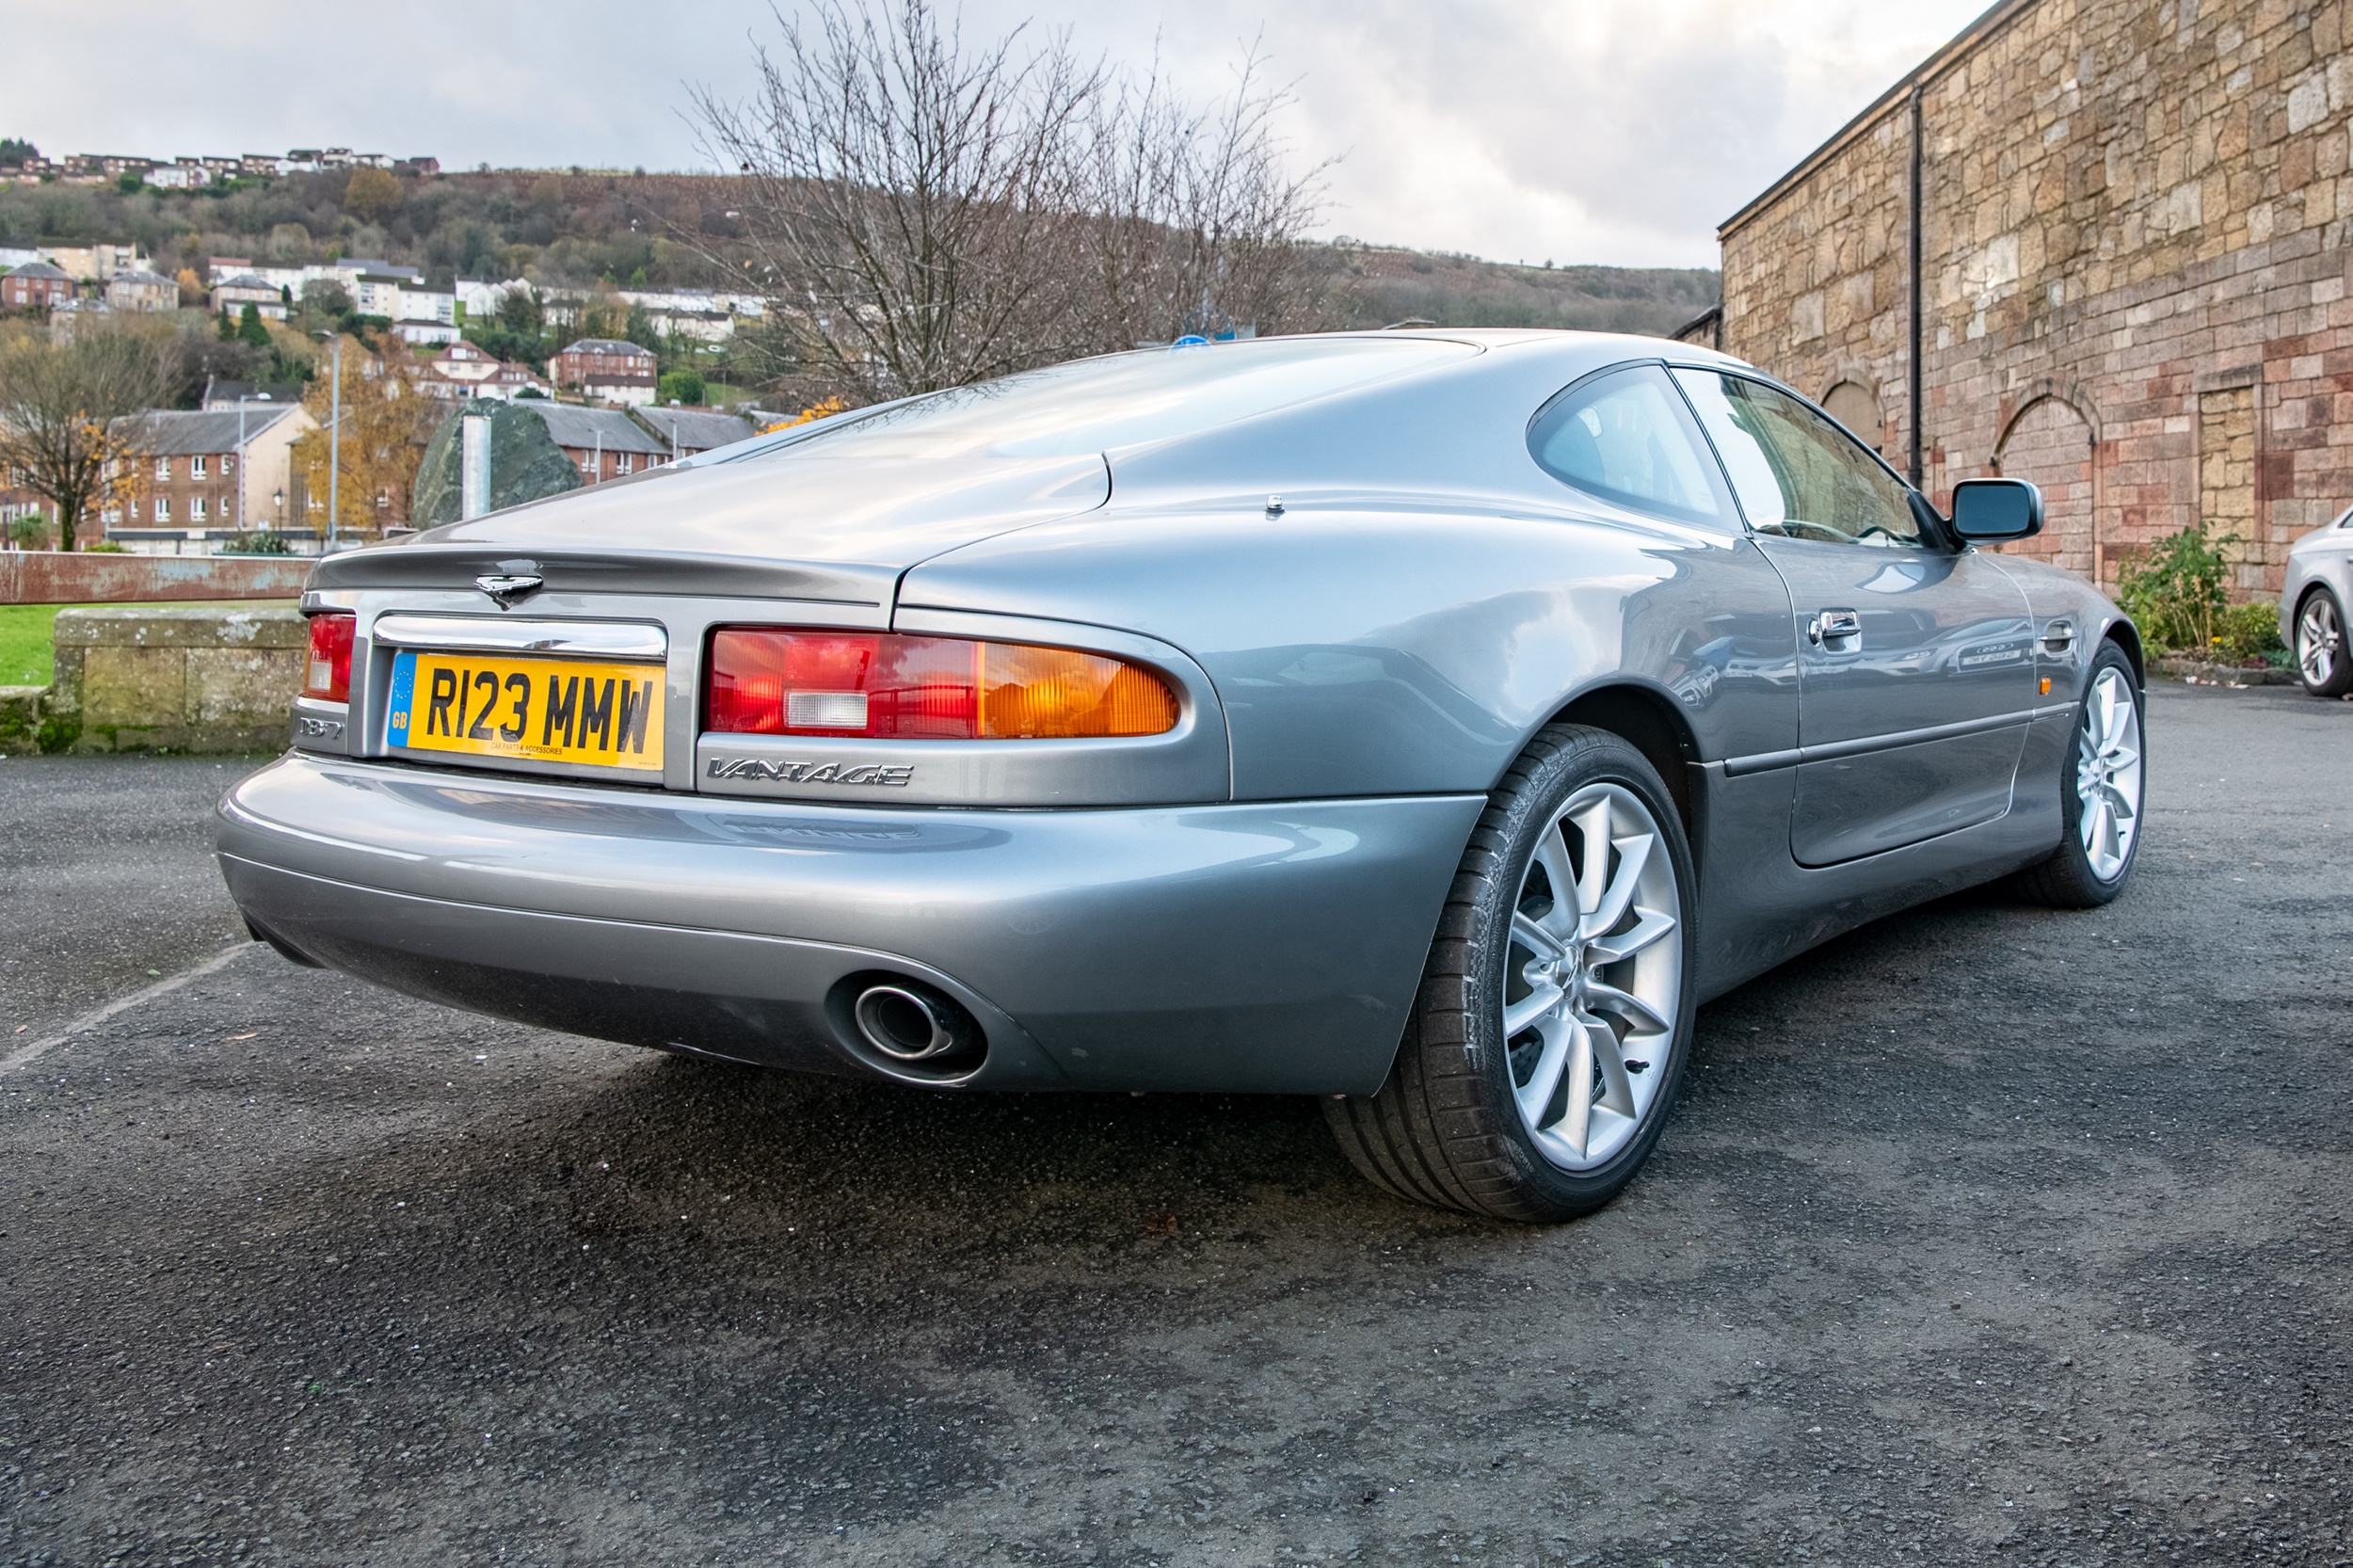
[[776, 337, 1478, 456]]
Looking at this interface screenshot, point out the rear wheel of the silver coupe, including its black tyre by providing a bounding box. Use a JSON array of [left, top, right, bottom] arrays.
[[1322, 725, 1697, 1222]]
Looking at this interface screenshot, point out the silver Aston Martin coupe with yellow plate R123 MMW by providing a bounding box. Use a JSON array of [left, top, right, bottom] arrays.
[[219, 332, 2141, 1220]]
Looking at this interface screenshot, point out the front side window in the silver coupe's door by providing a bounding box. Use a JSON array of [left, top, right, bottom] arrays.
[[1675, 370, 1923, 546]]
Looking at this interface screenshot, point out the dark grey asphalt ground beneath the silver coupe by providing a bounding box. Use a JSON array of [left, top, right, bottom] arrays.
[[0, 687, 2353, 1565]]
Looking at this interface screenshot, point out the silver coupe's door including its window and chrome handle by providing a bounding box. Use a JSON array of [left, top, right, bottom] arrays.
[[1675, 370, 2036, 867]]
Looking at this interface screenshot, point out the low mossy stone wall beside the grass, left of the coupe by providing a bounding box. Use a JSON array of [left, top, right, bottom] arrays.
[[38, 605, 309, 751]]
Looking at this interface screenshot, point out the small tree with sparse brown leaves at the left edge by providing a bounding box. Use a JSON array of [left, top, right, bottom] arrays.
[[0, 328, 172, 551]]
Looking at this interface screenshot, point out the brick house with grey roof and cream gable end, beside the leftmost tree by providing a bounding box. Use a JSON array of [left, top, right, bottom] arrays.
[[104, 403, 318, 535]]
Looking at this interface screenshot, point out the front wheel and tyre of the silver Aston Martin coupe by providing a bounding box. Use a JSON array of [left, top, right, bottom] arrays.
[[2012, 643, 2149, 909]]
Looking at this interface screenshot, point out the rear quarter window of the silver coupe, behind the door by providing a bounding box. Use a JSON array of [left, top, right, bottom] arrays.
[[1528, 365, 1739, 527]]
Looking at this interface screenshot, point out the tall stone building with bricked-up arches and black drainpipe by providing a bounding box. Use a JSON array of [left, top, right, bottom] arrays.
[[1694, 0, 2353, 596]]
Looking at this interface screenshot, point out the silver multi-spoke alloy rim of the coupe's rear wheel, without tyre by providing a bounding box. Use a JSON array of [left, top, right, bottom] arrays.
[[1504, 784, 1683, 1170]]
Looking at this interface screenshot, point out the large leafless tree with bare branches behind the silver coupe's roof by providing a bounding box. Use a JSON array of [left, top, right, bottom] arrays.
[[695, 0, 1316, 403]]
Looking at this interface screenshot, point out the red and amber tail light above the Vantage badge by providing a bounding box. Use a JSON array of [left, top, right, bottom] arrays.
[[704, 629, 1176, 739]]
